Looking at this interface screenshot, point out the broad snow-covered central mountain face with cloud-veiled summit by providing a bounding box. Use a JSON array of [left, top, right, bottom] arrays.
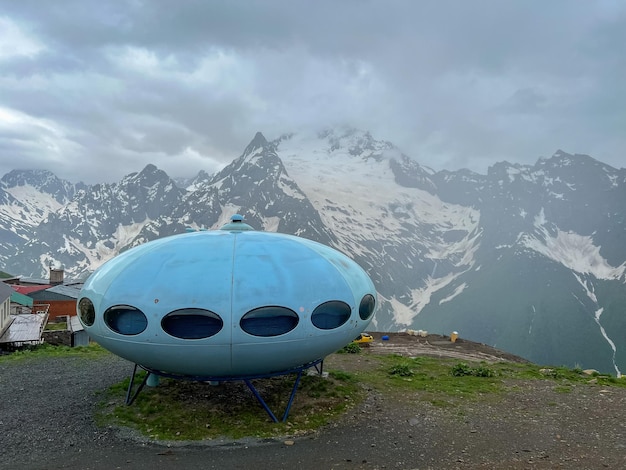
[[278, 131, 480, 331]]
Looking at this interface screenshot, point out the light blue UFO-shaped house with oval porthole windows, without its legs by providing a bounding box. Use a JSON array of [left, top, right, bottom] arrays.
[[77, 216, 376, 380]]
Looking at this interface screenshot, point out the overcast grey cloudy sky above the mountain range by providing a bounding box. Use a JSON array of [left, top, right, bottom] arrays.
[[0, 0, 626, 183]]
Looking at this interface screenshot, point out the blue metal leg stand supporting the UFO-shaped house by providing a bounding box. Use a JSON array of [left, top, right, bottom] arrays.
[[126, 359, 324, 423]]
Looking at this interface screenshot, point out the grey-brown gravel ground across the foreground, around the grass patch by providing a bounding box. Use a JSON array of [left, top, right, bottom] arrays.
[[0, 342, 626, 470]]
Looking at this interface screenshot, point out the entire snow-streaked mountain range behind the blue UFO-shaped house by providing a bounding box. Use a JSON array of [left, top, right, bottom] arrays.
[[0, 129, 626, 374]]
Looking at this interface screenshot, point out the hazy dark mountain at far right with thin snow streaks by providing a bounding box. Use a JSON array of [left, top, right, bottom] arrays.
[[416, 151, 626, 375]]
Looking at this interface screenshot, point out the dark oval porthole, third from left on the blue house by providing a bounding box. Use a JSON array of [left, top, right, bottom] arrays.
[[161, 308, 224, 339]]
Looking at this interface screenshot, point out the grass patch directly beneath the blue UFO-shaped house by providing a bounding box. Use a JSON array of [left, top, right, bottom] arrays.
[[97, 371, 364, 440]]
